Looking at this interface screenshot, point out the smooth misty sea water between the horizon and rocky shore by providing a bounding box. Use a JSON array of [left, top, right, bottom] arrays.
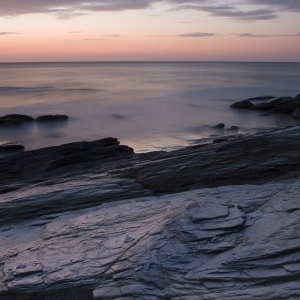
[[0, 62, 300, 152]]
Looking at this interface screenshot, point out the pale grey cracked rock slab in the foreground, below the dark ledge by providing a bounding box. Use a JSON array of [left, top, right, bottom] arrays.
[[0, 180, 300, 300]]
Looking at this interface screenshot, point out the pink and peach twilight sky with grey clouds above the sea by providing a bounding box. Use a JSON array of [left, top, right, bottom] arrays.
[[0, 0, 300, 62]]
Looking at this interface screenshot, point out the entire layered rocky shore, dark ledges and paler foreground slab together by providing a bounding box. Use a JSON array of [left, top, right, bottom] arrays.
[[0, 123, 300, 300]]
